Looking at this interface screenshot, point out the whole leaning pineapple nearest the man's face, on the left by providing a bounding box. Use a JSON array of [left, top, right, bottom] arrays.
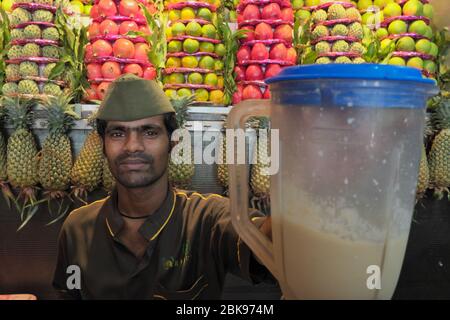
[[70, 116, 103, 201]]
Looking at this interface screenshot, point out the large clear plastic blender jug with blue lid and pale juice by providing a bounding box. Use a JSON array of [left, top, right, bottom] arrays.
[[228, 64, 437, 299]]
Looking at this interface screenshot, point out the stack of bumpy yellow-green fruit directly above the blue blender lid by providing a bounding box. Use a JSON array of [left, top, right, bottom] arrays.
[[311, 1, 366, 64]]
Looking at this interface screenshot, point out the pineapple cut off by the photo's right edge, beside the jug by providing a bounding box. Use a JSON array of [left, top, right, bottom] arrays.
[[429, 102, 450, 198]]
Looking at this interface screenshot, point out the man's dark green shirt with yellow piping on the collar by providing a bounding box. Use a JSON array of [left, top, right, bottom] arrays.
[[53, 189, 267, 299]]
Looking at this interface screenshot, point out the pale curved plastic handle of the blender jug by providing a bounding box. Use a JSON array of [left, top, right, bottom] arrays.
[[227, 99, 279, 279]]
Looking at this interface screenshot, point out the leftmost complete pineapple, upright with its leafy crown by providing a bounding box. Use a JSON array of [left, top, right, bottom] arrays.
[[2, 96, 39, 230]]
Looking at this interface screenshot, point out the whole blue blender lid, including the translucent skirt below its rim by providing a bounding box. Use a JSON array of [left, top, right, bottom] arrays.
[[266, 63, 438, 109]]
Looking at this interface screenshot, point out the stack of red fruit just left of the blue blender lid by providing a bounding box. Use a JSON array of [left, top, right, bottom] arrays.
[[233, 0, 297, 103]]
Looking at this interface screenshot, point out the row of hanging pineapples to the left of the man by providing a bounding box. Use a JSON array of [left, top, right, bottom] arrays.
[[0, 93, 115, 230]]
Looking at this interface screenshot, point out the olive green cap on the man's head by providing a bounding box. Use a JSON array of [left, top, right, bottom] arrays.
[[97, 74, 175, 121]]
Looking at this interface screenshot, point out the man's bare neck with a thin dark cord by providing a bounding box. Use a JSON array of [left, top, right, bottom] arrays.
[[117, 176, 168, 217]]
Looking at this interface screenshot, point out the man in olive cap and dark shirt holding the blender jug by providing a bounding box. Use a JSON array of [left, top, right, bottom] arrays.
[[53, 75, 271, 299]]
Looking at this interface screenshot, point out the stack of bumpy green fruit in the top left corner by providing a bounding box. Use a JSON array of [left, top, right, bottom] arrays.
[[2, 0, 65, 98]]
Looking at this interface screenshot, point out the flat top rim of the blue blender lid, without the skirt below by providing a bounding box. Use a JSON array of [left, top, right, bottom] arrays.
[[265, 63, 435, 85]]
